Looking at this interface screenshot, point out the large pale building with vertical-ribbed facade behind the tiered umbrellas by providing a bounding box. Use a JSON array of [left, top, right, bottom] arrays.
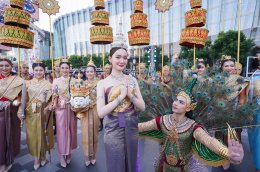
[[54, 0, 260, 57]]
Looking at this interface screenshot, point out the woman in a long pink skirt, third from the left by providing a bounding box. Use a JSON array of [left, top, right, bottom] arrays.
[[52, 59, 77, 168]]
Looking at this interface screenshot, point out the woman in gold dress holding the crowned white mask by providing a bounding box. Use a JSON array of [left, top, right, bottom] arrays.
[[71, 61, 99, 166]]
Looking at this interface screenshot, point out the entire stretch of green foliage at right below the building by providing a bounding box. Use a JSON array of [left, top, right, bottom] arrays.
[[180, 30, 255, 65]]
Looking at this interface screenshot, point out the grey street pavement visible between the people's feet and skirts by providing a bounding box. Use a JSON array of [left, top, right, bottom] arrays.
[[10, 126, 254, 172]]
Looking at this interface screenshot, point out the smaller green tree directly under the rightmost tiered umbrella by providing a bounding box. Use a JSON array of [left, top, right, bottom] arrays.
[[180, 40, 214, 65]]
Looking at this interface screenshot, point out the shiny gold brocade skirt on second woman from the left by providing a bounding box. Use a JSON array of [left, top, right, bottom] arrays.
[[26, 102, 54, 158]]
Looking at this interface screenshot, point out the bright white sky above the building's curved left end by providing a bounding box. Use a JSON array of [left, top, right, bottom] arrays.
[[35, 0, 94, 31]]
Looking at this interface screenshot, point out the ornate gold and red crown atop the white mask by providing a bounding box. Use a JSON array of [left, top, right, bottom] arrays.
[[70, 78, 89, 97]]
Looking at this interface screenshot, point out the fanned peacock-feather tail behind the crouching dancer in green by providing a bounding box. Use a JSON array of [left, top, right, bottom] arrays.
[[139, 60, 260, 131]]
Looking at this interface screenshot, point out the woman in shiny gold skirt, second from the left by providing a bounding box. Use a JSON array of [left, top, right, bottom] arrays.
[[18, 61, 54, 170]]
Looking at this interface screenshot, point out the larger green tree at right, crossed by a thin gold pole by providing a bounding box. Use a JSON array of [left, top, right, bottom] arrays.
[[210, 30, 255, 65]]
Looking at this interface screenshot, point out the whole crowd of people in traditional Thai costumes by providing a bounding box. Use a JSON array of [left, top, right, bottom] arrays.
[[0, 44, 260, 172]]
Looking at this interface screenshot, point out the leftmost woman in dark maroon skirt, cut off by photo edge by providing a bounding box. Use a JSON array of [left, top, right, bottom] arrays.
[[0, 57, 23, 172]]
